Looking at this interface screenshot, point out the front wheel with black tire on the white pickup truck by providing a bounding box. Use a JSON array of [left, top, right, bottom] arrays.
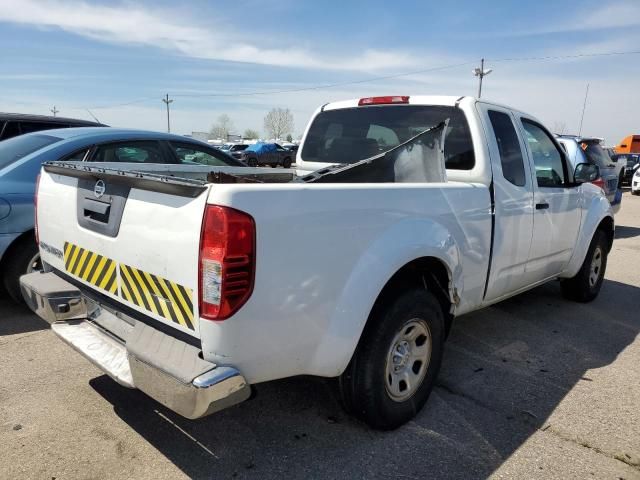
[[560, 230, 608, 303]]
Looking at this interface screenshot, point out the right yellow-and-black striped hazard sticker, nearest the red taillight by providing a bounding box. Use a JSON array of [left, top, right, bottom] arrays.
[[119, 263, 195, 330]]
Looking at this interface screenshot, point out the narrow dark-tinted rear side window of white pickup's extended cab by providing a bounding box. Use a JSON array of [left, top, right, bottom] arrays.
[[489, 110, 526, 187]]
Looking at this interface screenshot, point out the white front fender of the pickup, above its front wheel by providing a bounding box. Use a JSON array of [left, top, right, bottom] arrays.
[[560, 185, 613, 278]]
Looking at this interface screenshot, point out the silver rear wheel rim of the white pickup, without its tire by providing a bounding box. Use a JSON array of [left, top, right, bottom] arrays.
[[385, 318, 432, 402]]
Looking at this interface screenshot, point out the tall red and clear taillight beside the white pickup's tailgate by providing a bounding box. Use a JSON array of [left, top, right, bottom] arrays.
[[199, 205, 256, 320]]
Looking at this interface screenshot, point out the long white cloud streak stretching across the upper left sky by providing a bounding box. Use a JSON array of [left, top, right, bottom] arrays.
[[0, 0, 428, 71]]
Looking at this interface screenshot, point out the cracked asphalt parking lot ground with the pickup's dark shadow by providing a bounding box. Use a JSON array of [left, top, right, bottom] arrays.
[[0, 192, 640, 479]]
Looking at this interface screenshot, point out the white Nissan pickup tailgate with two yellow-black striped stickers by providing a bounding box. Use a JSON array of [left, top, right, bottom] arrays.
[[37, 165, 209, 338]]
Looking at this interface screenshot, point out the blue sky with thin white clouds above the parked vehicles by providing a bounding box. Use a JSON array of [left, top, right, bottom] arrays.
[[0, 0, 640, 144]]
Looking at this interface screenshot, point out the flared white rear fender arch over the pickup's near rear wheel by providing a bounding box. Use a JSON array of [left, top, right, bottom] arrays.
[[308, 219, 463, 377]]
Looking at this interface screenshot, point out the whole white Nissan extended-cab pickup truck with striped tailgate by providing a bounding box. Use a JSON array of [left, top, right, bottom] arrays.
[[21, 96, 614, 429]]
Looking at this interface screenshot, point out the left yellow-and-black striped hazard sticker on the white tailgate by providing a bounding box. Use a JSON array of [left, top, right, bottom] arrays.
[[64, 242, 118, 295]]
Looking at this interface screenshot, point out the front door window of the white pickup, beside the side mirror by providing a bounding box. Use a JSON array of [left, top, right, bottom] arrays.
[[522, 118, 566, 188]]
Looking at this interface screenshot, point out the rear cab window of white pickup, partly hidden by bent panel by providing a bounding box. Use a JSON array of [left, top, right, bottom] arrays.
[[300, 105, 475, 170]]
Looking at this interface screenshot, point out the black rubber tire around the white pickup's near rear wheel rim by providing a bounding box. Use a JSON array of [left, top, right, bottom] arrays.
[[338, 289, 445, 430]]
